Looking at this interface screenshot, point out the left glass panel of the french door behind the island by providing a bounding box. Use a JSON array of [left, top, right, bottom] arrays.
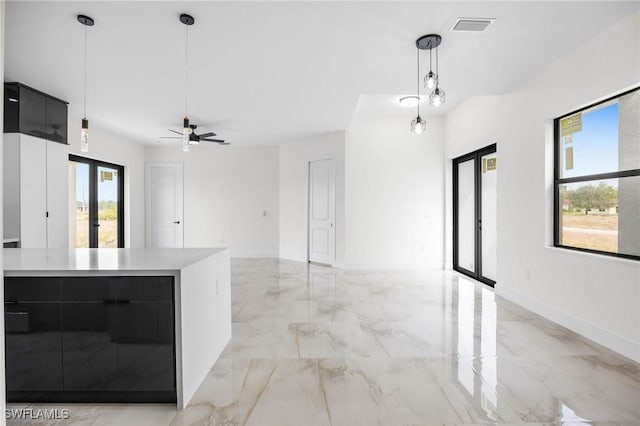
[[69, 161, 90, 248]]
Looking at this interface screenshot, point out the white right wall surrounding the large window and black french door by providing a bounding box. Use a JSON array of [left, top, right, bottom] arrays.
[[446, 12, 640, 361]]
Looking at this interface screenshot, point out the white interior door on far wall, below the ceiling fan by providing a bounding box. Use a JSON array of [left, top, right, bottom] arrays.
[[146, 163, 184, 248]]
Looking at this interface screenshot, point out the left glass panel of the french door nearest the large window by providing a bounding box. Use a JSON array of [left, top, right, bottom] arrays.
[[458, 159, 476, 272]]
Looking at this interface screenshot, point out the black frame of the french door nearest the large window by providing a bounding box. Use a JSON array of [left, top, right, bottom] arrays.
[[451, 143, 498, 287]]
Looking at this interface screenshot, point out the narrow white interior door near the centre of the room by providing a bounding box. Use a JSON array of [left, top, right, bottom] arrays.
[[308, 159, 335, 264]]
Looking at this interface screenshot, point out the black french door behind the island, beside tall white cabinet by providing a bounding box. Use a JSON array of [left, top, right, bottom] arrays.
[[69, 155, 124, 248]]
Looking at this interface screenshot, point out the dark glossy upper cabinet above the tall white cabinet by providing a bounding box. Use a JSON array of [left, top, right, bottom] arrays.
[[4, 83, 67, 144]]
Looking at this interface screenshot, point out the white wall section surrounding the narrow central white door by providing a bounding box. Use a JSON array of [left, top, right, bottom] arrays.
[[279, 132, 345, 266]]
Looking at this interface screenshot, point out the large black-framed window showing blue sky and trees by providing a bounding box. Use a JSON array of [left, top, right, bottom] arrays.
[[554, 88, 640, 260]]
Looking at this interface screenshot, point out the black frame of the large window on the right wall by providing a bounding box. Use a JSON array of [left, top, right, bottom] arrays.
[[553, 86, 640, 260]]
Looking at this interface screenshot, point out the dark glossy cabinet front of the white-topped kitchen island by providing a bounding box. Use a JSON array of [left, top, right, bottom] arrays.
[[5, 277, 176, 402]]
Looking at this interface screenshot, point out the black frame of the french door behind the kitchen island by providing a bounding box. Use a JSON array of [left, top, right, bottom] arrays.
[[69, 154, 125, 248]]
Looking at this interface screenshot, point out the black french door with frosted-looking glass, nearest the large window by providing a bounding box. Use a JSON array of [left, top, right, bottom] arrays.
[[453, 144, 498, 287]]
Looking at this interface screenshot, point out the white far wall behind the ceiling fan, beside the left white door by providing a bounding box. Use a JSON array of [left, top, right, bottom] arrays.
[[143, 143, 279, 257]]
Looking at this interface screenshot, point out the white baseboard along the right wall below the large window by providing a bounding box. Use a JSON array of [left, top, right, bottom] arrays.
[[496, 285, 640, 362]]
